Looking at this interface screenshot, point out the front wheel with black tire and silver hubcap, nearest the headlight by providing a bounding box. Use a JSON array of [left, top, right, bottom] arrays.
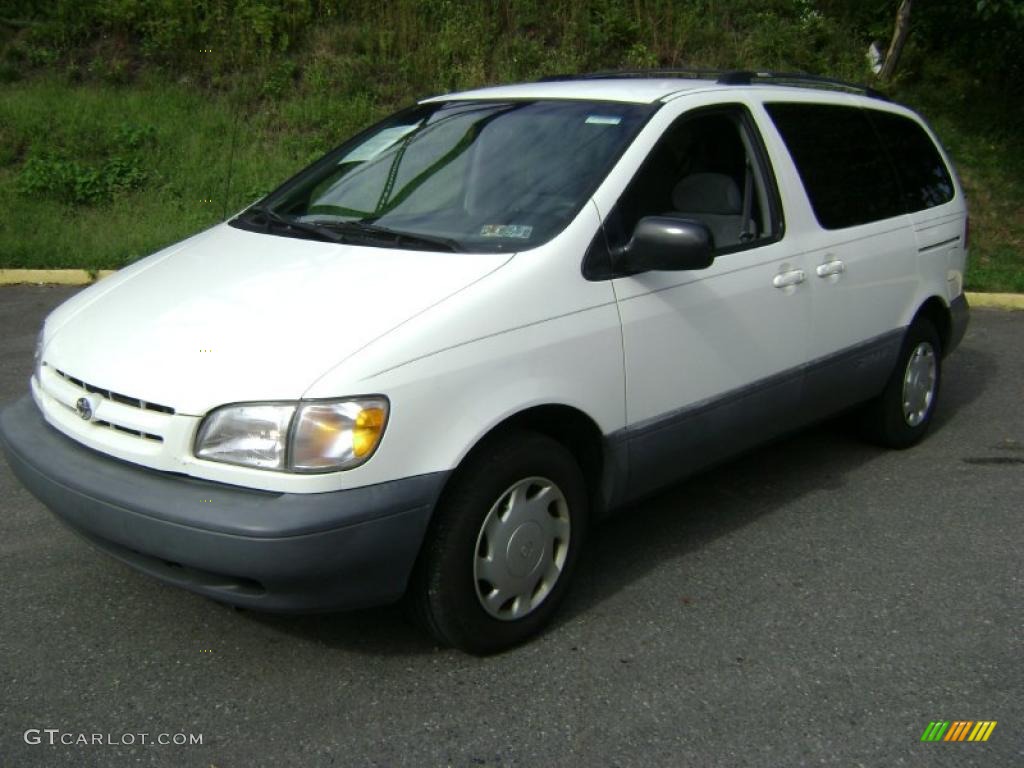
[[409, 431, 587, 653]]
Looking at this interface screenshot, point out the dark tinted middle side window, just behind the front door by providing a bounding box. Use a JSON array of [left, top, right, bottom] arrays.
[[765, 103, 905, 229]]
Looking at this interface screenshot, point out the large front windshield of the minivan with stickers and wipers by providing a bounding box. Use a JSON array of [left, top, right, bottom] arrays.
[[231, 100, 654, 252]]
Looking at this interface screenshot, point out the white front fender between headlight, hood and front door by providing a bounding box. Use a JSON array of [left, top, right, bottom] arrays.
[[305, 206, 626, 482]]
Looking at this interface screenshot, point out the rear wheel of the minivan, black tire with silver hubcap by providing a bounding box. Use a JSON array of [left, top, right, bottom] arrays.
[[861, 317, 942, 449]]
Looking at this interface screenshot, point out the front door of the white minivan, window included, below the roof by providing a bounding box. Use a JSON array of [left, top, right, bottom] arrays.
[[593, 104, 811, 498]]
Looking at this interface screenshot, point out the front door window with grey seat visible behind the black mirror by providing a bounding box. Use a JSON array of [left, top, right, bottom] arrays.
[[604, 105, 781, 253]]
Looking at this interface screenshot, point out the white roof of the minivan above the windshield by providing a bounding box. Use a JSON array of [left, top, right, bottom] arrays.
[[424, 78, 716, 103]]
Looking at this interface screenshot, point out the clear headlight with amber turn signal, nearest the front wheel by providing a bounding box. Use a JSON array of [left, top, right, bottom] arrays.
[[196, 397, 388, 472]]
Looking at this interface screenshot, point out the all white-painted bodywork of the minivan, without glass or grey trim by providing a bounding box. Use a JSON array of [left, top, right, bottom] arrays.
[[33, 80, 964, 493]]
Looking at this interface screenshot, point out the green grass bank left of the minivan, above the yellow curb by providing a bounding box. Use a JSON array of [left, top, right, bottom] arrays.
[[0, 79, 387, 269]]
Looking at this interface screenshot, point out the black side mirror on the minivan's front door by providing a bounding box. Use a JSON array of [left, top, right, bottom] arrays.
[[613, 216, 715, 272]]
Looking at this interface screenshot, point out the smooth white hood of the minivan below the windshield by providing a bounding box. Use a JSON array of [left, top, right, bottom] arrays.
[[44, 224, 509, 415]]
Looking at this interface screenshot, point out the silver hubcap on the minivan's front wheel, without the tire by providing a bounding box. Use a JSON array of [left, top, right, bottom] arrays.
[[473, 477, 570, 621]]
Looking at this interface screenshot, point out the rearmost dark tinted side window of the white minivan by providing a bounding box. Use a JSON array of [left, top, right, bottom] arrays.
[[865, 110, 953, 213]]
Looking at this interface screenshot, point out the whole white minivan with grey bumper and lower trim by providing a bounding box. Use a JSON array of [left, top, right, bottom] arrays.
[[0, 72, 968, 652]]
